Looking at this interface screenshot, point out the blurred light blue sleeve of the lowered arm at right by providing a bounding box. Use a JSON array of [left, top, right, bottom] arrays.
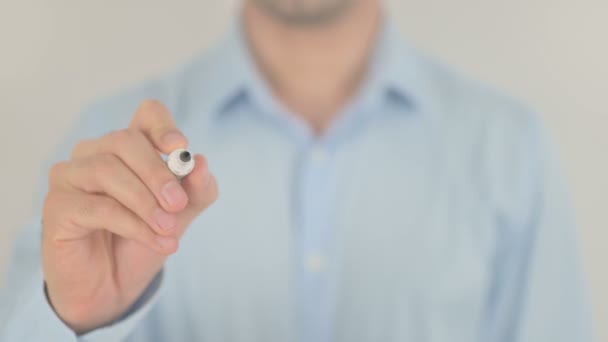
[[480, 115, 595, 342]]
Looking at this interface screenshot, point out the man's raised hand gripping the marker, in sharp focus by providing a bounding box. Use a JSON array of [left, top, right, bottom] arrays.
[[42, 101, 218, 333]]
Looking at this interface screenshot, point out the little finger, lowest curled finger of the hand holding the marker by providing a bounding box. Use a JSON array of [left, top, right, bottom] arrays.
[[45, 192, 177, 255]]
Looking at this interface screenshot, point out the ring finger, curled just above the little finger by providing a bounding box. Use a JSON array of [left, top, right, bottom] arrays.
[[54, 154, 178, 235]]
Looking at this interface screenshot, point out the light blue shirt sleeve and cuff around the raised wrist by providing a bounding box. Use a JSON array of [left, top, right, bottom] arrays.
[[0, 221, 163, 342]]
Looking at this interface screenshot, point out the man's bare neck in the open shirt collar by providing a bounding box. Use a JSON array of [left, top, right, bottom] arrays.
[[243, 1, 381, 134]]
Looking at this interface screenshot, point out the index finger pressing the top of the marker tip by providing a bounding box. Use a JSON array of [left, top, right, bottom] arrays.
[[129, 100, 188, 154]]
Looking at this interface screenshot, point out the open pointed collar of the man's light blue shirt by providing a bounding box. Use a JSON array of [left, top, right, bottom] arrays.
[[198, 18, 429, 119]]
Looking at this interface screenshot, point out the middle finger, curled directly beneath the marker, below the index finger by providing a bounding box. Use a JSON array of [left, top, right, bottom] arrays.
[[72, 130, 188, 213]]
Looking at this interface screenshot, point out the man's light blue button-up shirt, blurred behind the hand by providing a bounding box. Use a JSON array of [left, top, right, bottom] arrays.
[[0, 19, 592, 342]]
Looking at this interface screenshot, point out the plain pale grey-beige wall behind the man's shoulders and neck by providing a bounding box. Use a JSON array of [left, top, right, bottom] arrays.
[[0, 0, 608, 341]]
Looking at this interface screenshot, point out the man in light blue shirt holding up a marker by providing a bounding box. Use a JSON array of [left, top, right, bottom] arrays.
[[0, 0, 591, 342]]
